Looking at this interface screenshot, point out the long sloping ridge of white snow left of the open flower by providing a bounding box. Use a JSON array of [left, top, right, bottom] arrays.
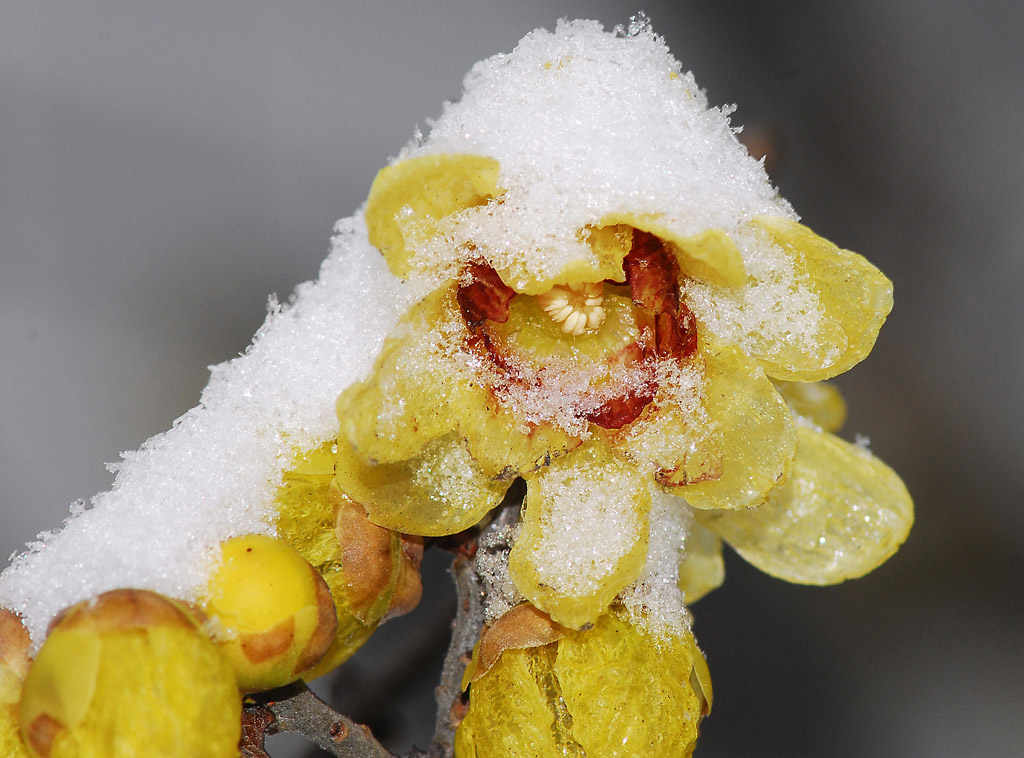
[[0, 216, 410, 644]]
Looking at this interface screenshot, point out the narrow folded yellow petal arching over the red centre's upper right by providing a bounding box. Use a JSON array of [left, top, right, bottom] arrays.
[[599, 213, 746, 287]]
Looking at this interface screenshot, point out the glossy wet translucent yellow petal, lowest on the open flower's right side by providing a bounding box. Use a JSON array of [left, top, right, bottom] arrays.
[[697, 427, 913, 585]]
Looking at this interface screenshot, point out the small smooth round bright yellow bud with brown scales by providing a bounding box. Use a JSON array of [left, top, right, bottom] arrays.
[[204, 535, 337, 691]]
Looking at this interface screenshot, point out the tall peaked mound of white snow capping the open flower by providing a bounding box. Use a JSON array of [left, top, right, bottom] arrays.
[[398, 20, 794, 292]]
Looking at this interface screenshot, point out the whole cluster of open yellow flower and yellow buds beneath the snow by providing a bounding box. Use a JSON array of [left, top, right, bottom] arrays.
[[0, 34, 913, 758]]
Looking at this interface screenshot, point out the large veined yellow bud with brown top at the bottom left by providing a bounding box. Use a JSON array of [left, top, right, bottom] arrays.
[[20, 589, 242, 758]]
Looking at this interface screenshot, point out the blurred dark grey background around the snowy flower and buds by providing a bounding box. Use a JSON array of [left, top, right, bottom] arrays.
[[0, 0, 1024, 758]]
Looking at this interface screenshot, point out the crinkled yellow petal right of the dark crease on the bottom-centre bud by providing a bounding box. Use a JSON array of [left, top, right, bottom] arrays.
[[553, 614, 708, 758]]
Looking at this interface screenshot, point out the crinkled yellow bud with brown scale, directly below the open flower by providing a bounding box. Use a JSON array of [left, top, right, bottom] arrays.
[[455, 606, 711, 758]]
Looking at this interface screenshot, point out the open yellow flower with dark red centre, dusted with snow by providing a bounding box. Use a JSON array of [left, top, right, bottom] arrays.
[[336, 155, 912, 629]]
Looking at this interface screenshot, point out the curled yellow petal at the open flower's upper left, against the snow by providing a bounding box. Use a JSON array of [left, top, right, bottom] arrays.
[[366, 154, 501, 278]]
